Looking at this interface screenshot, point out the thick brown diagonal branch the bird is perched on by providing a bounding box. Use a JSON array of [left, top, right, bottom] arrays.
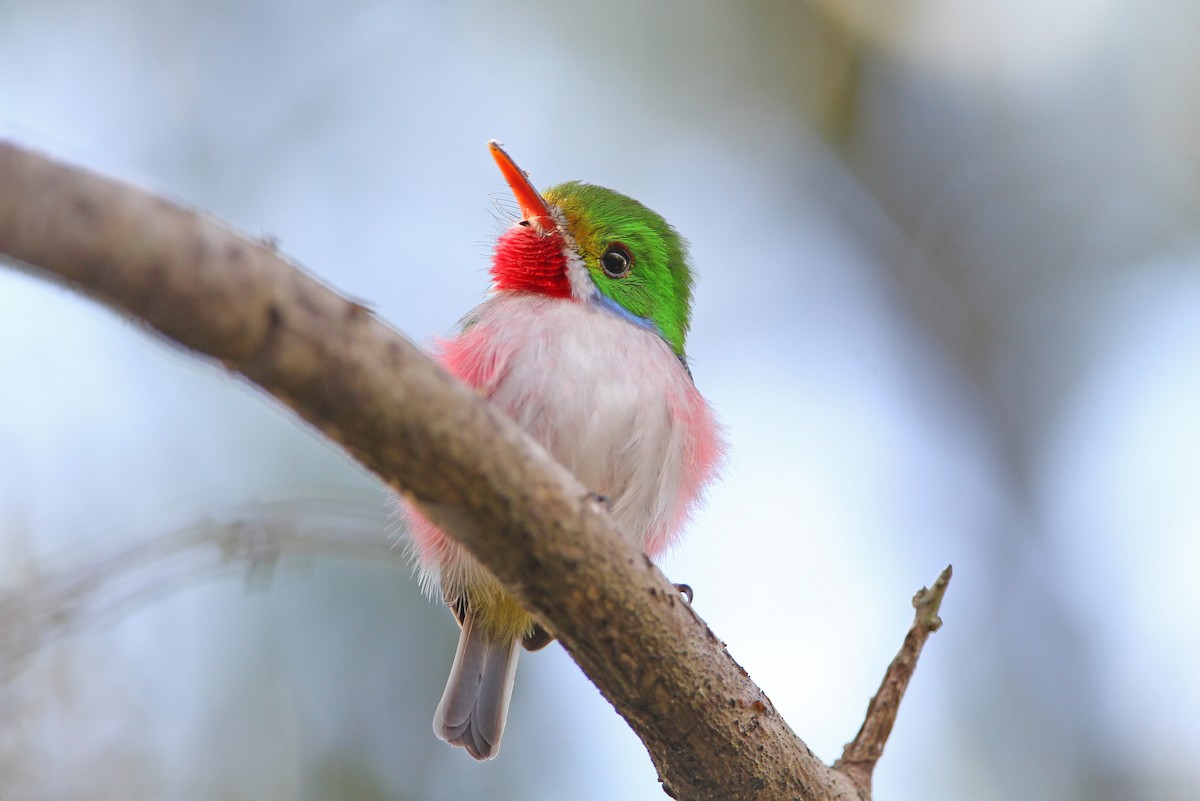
[[0, 144, 945, 801]]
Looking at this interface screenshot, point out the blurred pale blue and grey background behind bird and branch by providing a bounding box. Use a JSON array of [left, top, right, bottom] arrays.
[[0, 0, 1200, 801]]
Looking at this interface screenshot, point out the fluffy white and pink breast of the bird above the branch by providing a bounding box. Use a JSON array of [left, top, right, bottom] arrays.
[[440, 293, 722, 555]]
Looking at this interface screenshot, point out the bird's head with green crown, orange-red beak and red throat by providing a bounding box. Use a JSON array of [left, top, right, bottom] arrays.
[[491, 141, 692, 359]]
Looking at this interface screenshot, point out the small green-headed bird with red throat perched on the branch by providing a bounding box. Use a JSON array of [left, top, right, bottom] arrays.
[[400, 140, 726, 761]]
